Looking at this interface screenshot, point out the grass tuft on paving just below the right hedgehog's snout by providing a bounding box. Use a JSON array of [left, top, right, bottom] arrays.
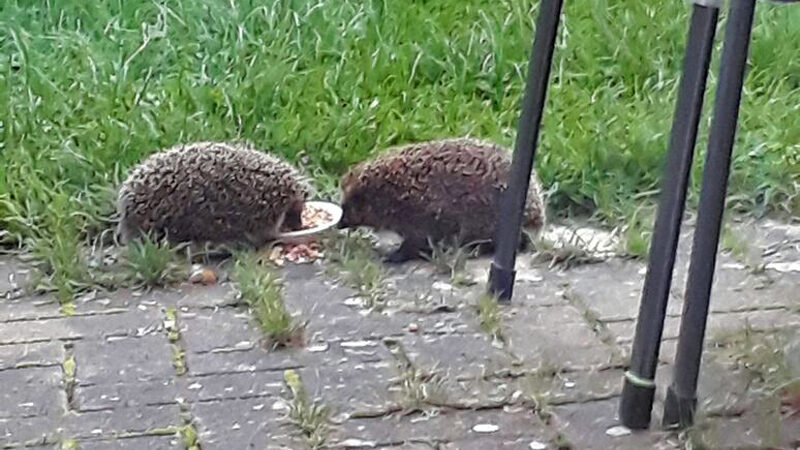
[[325, 232, 387, 309]]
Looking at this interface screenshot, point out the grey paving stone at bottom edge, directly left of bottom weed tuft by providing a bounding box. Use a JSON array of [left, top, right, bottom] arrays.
[[191, 398, 303, 450]]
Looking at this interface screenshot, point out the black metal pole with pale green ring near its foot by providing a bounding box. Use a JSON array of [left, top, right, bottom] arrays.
[[619, 4, 719, 429]]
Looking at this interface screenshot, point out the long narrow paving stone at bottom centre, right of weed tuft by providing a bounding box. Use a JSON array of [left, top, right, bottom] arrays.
[[329, 408, 551, 448]]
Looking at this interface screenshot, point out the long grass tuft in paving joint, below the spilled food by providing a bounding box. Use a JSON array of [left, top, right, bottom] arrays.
[[231, 253, 305, 348]]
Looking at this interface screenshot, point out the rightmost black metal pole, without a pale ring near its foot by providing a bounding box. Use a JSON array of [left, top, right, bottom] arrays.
[[663, 0, 756, 427]]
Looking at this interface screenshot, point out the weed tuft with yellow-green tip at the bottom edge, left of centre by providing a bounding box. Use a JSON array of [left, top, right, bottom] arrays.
[[283, 370, 330, 450]]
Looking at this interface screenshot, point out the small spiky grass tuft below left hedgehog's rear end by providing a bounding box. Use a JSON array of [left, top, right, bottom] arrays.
[[124, 236, 187, 287]]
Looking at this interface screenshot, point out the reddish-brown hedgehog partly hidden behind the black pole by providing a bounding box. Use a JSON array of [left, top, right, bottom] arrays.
[[340, 138, 545, 262]]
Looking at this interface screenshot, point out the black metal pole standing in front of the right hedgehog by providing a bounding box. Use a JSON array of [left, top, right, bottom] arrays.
[[489, 0, 563, 301]]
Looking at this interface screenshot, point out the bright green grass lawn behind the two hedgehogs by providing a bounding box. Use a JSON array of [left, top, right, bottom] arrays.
[[0, 0, 800, 248]]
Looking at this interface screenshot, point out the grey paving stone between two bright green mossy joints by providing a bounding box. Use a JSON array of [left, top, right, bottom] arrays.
[[73, 335, 175, 385]]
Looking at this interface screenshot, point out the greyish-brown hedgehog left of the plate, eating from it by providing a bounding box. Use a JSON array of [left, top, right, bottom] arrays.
[[117, 142, 309, 247]]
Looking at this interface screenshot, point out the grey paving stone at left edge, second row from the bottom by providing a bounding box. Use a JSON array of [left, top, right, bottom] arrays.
[[0, 367, 66, 418]]
